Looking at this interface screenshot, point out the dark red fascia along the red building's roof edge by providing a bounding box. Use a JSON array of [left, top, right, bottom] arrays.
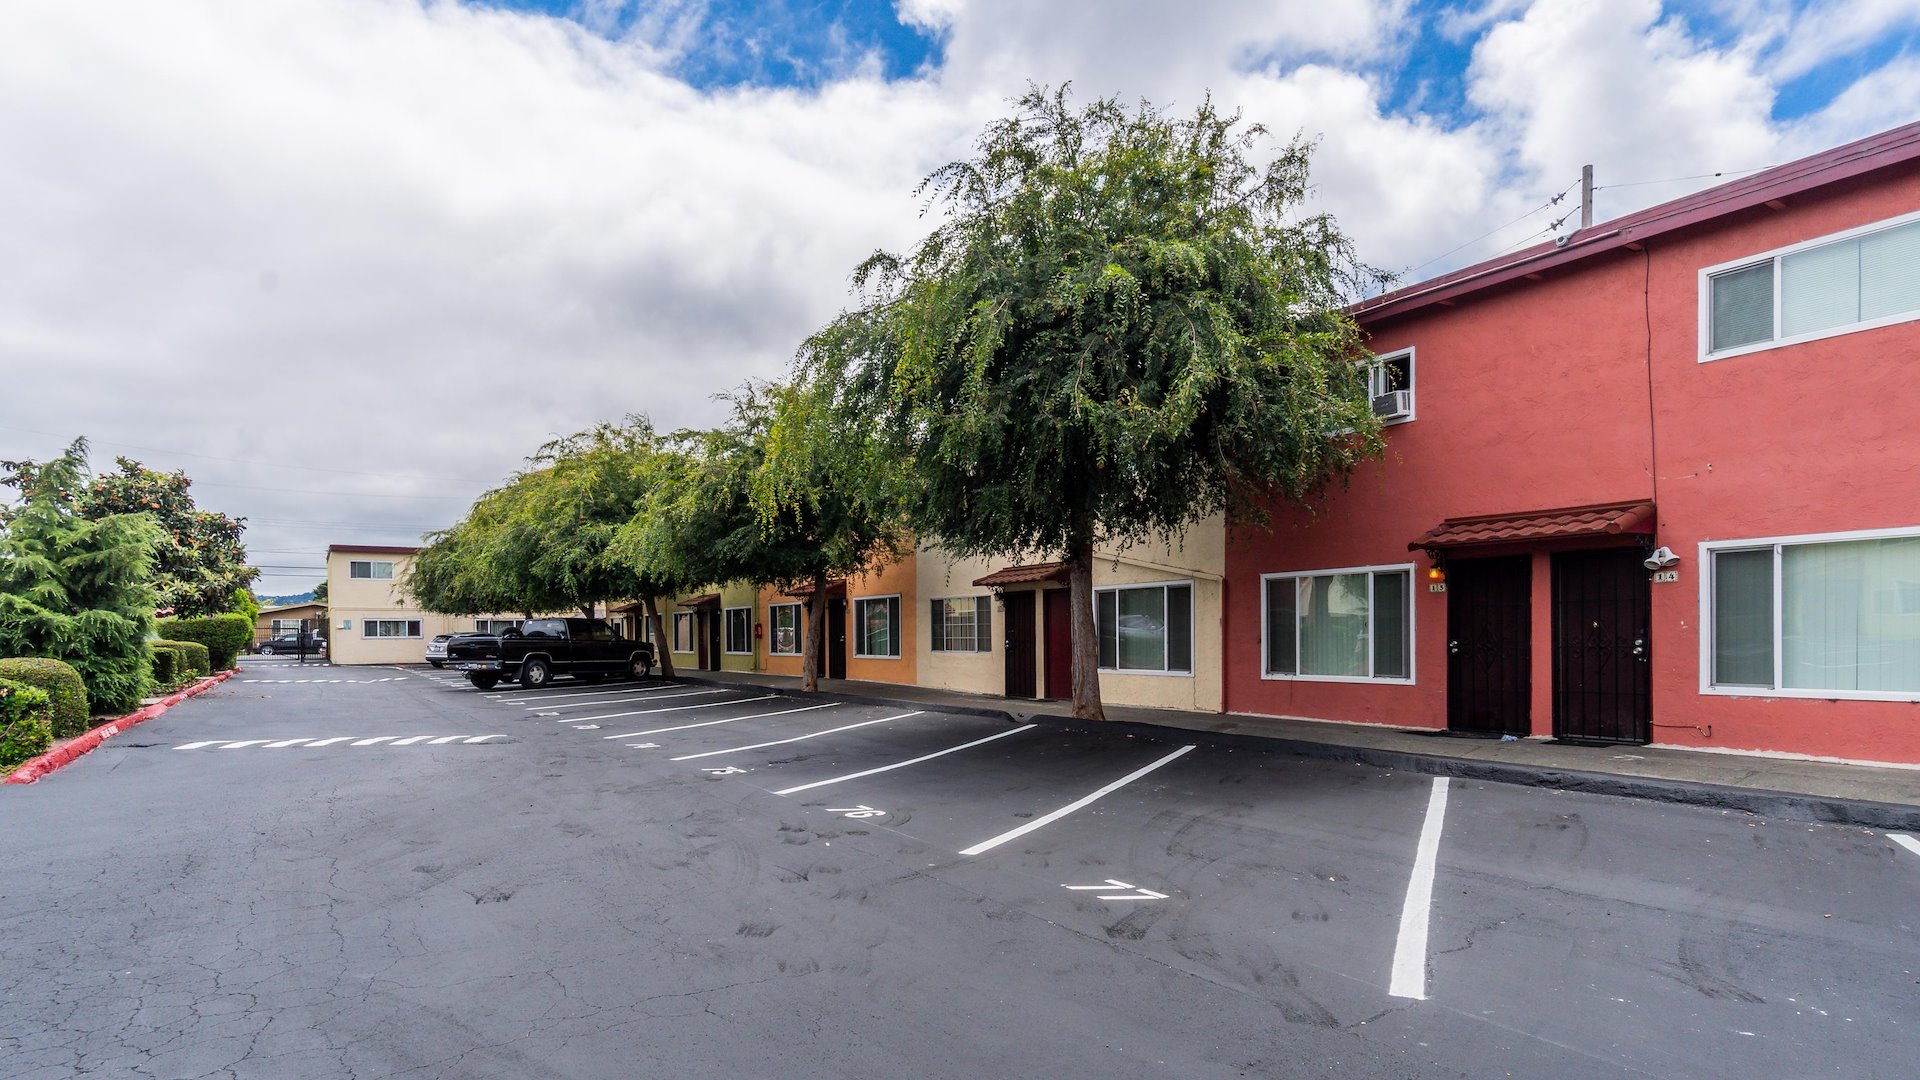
[[1348, 121, 1920, 325]]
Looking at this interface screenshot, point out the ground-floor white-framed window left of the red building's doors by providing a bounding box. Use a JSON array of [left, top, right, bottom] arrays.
[[1260, 563, 1413, 682]]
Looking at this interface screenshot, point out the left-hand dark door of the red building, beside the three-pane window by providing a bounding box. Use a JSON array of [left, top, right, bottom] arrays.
[[1446, 555, 1532, 734]]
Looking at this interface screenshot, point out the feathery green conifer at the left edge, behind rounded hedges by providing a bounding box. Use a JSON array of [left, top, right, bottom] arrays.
[[0, 438, 159, 713]]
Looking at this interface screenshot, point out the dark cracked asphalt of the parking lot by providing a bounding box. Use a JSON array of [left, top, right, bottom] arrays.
[[0, 661, 1920, 1080]]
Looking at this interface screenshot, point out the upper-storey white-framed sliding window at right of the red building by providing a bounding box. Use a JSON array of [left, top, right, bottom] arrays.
[[1699, 213, 1920, 361]]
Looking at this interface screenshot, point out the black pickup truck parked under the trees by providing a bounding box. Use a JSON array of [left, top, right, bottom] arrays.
[[445, 619, 653, 690]]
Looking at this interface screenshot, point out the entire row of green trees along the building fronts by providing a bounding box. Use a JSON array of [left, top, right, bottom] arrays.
[[411, 88, 1382, 719]]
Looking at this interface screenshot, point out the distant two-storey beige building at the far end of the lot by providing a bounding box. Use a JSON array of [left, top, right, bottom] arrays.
[[326, 544, 520, 663]]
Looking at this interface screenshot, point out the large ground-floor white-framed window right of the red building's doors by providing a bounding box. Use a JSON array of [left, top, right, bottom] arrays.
[[1699, 527, 1920, 701]]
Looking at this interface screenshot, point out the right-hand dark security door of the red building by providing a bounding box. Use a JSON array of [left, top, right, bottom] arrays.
[[1553, 548, 1653, 742]]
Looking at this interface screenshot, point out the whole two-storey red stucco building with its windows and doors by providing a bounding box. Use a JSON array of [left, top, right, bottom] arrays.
[[1225, 123, 1920, 763]]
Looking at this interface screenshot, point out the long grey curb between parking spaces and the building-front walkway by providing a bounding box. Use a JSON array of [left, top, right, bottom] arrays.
[[678, 676, 1920, 832]]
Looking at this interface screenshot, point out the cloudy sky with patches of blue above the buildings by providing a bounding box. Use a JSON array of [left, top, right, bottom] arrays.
[[0, 0, 1920, 594]]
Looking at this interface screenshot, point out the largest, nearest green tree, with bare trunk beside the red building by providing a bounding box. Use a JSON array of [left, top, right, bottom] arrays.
[[799, 88, 1380, 719]]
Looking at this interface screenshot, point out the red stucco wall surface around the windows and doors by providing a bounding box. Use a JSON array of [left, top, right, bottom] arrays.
[[1225, 171, 1920, 761]]
